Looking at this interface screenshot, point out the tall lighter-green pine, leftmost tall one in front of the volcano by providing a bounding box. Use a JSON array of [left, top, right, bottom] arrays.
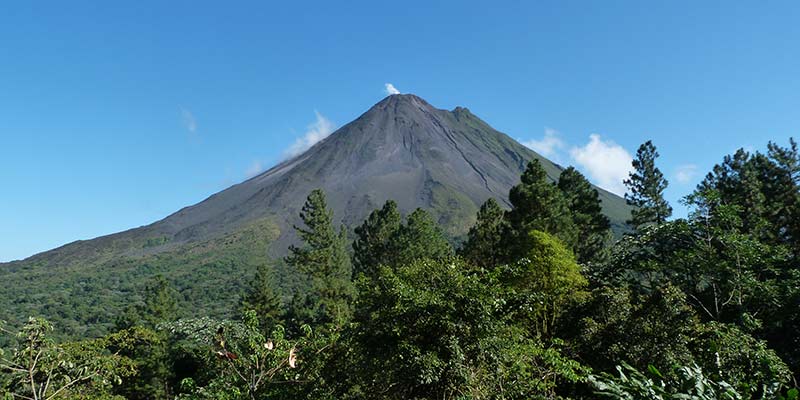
[[286, 189, 354, 323]]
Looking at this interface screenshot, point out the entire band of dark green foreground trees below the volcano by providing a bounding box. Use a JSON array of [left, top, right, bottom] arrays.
[[0, 141, 800, 400]]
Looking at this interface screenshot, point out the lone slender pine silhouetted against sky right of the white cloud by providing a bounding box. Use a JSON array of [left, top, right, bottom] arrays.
[[624, 140, 672, 229]]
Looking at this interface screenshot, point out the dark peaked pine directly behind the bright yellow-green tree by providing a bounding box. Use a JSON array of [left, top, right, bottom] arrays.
[[505, 159, 577, 262]]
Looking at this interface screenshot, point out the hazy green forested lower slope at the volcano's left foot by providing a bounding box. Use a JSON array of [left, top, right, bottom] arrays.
[[0, 220, 282, 338]]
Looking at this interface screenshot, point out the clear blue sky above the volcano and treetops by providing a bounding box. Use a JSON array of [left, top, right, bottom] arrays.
[[0, 1, 800, 261]]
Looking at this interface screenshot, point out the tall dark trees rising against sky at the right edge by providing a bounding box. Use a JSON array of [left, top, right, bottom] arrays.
[[687, 140, 800, 378]]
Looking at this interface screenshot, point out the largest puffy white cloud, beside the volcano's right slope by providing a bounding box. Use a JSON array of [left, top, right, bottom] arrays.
[[570, 134, 633, 196]]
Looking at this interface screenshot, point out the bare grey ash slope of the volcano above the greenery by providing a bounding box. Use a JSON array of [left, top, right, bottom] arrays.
[[7, 94, 629, 264]]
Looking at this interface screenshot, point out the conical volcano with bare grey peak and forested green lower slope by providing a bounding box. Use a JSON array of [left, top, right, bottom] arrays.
[[0, 94, 630, 334]]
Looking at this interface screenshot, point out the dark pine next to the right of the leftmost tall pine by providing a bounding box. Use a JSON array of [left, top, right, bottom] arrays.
[[353, 200, 403, 276]]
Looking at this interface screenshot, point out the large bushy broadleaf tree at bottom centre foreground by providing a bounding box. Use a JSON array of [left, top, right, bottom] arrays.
[[346, 259, 586, 399]]
